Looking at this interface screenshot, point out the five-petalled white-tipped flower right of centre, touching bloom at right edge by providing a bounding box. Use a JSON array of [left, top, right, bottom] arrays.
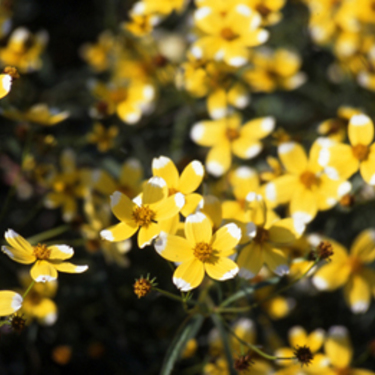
[[263, 139, 351, 223]]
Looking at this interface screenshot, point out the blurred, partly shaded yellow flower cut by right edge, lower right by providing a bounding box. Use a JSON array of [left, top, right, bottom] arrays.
[[312, 229, 375, 314]]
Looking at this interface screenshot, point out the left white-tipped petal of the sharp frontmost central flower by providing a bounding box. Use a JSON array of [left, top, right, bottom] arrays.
[[154, 232, 194, 262]]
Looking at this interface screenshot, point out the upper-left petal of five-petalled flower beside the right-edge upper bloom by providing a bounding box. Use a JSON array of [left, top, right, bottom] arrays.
[[277, 142, 307, 174]]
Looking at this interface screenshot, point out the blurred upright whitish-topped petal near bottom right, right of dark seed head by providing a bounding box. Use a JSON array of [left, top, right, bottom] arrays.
[[324, 326, 353, 368]]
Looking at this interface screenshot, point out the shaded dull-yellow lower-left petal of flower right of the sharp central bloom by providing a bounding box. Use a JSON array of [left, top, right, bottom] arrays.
[[237, 242, 263, 279]]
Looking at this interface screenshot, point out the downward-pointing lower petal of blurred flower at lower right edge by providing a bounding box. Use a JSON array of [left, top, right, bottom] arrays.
[[344, 274, 371, 314]]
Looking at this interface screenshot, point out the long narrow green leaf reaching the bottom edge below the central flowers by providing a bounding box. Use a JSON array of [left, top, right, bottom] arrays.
[[160, 314, 204, 375]]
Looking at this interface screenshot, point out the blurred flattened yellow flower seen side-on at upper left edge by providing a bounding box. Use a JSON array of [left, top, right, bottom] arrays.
[[1, 103, 70, 126]]
